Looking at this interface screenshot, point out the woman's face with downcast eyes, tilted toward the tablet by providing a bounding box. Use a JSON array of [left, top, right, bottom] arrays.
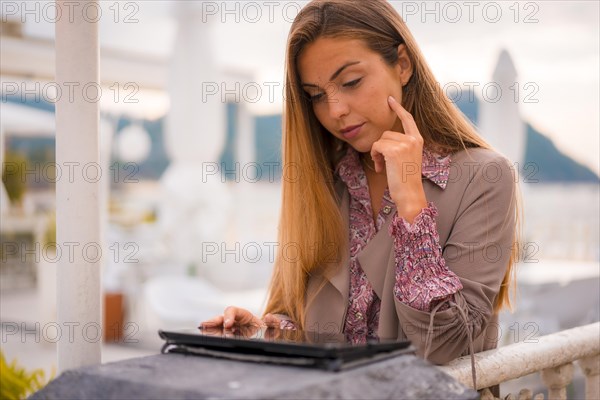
[[298, 38, 412, 153]]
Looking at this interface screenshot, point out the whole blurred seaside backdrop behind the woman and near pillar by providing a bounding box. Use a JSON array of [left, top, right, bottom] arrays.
[[0, 1, 600, 394]]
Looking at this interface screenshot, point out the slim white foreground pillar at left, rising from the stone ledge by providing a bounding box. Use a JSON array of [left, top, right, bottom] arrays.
[[56, 0, 101, 372]]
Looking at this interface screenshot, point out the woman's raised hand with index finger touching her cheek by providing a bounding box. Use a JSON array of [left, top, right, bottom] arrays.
[[371, 96, 427, 223]]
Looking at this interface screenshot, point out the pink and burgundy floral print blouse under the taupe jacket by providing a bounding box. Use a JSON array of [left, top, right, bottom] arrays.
[[281, 147, 462, 336]]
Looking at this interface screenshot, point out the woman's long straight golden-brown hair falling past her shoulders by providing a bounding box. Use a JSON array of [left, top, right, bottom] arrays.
[[265, 0, 520, 328]]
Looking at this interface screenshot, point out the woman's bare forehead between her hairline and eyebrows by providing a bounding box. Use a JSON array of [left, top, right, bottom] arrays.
[[297, 38, 378, 82]]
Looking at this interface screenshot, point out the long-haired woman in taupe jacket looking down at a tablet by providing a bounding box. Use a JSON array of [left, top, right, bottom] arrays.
[[204, 0, 519, 384]]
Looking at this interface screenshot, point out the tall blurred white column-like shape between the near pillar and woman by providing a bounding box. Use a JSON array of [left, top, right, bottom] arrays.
[[159, 1, 232, 274]]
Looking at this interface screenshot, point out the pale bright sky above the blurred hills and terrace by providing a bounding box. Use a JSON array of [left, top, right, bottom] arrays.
[[3, 0, 600, 173]]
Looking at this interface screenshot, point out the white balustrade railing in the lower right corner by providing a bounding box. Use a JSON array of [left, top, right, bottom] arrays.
[[439, 322, 600, 400]]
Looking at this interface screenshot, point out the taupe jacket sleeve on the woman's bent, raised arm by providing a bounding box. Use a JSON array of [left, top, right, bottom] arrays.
[[394, 153, 516, 364]]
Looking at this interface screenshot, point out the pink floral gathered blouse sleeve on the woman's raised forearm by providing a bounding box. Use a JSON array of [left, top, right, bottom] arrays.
[[389, 202, 462, 311]]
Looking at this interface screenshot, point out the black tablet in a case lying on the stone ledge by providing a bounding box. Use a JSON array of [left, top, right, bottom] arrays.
[[159, 327, 414, 371]]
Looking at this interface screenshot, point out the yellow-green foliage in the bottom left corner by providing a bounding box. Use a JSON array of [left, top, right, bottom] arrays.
[[0, 350, 52, 400]]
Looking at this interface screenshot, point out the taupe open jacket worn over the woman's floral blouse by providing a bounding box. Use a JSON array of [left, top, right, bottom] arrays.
[[305, 148, 515, 364]]
